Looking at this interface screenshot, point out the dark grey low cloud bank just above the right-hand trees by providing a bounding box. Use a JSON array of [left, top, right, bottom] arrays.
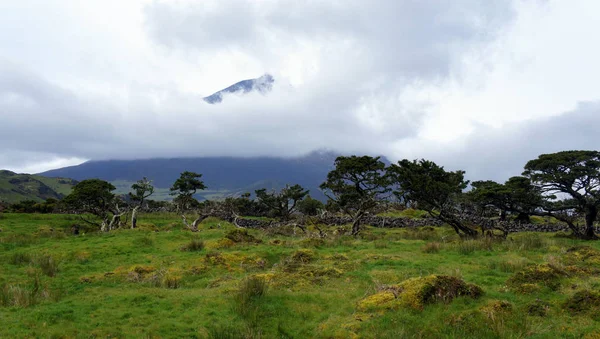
[[408, 101, 600, 182]]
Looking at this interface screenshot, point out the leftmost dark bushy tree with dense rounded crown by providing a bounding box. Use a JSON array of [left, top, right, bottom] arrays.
[[63, 179, 126, 232]]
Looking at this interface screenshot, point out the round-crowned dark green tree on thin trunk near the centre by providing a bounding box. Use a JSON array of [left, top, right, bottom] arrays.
[[320, 155, 390, 235]]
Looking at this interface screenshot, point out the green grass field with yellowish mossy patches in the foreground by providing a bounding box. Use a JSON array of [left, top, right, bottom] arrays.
[[0, 214, 600, 338]]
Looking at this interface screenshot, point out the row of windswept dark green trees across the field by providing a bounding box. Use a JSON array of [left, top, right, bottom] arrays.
[[58, 151, 600, 239]]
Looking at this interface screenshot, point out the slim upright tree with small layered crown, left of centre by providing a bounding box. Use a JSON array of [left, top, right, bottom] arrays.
[[170, 171, 208, 232]]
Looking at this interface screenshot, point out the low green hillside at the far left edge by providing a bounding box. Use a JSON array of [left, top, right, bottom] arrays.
[[0, 170, 77, 203]]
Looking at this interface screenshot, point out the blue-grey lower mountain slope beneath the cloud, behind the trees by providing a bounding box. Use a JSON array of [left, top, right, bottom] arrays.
[[41, 152, 337, 199]]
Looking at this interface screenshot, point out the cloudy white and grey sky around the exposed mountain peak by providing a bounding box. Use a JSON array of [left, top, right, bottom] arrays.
[[0, 0, 600, 180]]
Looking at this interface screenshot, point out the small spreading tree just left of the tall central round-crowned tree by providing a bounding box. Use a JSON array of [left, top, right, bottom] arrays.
[[255, 184, 308, 221]]
